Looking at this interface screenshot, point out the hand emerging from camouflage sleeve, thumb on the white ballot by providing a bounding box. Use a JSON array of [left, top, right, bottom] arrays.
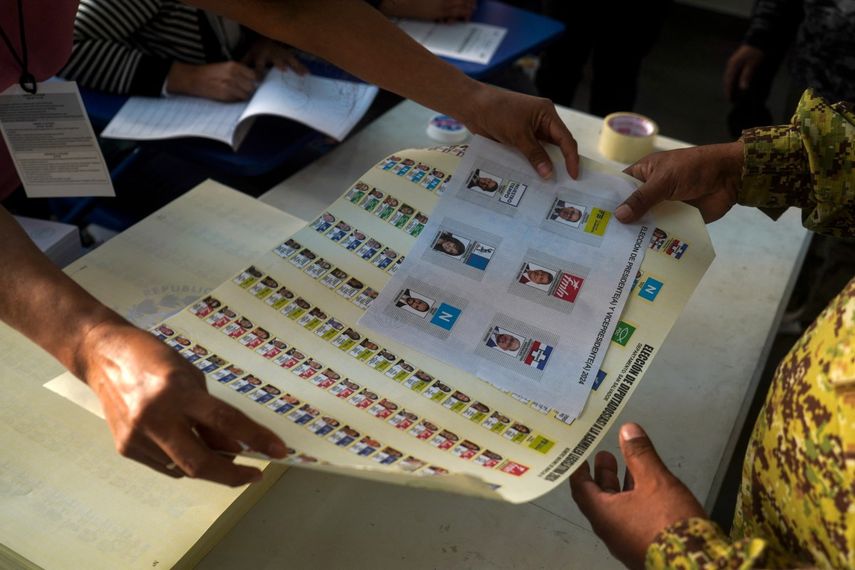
[[615, 141, 744, 224]]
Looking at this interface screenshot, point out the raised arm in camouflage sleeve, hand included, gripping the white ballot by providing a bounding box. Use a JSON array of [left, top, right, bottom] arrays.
[[615, 90, 855, 236]]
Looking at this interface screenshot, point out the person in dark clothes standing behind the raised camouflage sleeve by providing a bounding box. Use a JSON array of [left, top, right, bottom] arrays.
[[723, 0, 855, 334]]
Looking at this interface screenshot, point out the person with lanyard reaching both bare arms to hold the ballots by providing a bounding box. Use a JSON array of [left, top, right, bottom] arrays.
[[0, 0, 579, 485]]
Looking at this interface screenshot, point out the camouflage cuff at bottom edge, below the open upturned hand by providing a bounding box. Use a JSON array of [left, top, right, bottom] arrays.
[[645, 518, 766, 570]]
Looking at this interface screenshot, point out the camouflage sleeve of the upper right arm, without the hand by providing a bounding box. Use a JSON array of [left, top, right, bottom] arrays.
[[737, 90, 855, 237]]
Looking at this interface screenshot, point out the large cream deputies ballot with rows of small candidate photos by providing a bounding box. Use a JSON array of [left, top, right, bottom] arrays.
[[48, 143, 714, 503]]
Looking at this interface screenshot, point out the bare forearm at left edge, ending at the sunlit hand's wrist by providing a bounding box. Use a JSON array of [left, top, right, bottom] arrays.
[[0, 207, 123, 377]]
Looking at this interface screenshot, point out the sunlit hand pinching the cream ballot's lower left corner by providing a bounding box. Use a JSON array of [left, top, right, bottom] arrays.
[[79, 319, 286, 486]]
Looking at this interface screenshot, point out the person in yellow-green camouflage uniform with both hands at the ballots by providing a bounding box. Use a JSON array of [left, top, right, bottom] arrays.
[[570, 91, 855, 569]]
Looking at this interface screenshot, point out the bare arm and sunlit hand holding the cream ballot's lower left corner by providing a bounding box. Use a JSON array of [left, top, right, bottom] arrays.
[[0, 208, 285, 485]]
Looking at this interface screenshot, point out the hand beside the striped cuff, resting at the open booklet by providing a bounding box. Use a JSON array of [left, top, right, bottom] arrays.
[[166, 61, 256, 103]]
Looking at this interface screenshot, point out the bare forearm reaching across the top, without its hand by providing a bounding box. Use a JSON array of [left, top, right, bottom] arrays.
[[186, 0, 480, 120]]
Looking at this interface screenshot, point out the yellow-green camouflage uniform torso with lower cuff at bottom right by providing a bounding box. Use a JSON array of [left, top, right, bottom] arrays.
[[647, 280, 855, 569]]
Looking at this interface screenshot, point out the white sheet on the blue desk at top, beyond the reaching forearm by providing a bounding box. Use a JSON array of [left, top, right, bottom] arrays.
[[397, 20, 508, 65]]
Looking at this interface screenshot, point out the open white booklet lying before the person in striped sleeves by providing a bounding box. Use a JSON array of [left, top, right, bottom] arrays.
[[101, 69, 377, 150]]
